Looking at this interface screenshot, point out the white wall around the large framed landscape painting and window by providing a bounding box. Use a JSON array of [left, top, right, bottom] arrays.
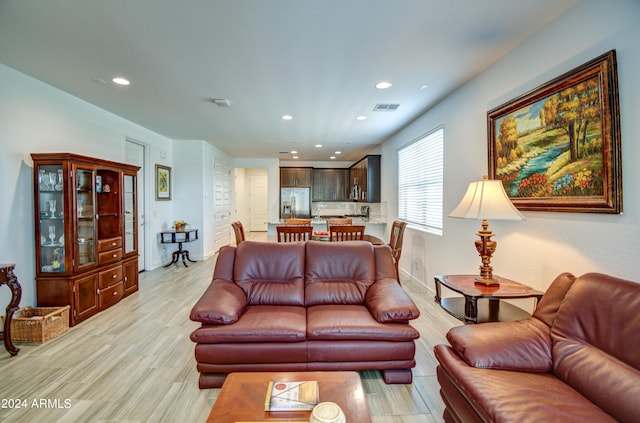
[[382, 0, 640, 290]]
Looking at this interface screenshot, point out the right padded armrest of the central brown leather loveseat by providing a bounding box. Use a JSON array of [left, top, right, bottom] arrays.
[[365, 278, 420, 323]]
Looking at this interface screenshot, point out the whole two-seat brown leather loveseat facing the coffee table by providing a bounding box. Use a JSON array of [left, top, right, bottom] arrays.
[[190, 241, 419, 388]]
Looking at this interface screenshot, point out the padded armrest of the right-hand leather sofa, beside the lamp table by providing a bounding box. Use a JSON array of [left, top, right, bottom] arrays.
[[447, 318, 553, 372]]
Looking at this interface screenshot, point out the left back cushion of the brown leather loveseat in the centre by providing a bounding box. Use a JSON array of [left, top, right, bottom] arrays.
[[233, 241, 305, 306]]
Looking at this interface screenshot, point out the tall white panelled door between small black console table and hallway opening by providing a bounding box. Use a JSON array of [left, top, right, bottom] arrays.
[[213, 159, 231, 251]]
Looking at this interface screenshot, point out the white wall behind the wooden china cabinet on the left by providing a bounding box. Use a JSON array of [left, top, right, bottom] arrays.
[[0, 65, 178, 307]]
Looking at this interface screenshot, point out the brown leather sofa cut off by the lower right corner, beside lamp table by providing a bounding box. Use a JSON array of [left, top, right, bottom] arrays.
[[434, 273, 640, 423]]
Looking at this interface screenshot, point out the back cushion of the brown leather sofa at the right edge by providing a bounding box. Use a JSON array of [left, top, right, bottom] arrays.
[[551, 273, 640, 421]]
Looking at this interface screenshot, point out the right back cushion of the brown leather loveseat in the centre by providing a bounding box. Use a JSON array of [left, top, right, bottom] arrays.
[[305, 241, 376, 306]]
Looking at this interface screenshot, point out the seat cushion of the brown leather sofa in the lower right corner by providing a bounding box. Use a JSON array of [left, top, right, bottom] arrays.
[[434, 345, 616, 423]]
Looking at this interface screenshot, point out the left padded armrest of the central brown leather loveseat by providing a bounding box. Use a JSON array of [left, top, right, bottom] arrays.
[[189, 279, 247, 325]]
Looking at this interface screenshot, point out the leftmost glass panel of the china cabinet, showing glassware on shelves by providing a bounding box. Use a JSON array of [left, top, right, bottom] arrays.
[[38, 163, 65, 272]]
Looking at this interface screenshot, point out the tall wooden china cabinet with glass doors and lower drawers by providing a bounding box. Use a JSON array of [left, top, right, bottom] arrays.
[[31, 153, 139, 326]]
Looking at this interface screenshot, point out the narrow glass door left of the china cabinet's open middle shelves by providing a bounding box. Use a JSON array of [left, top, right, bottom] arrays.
[[74, 168, 96, 268]]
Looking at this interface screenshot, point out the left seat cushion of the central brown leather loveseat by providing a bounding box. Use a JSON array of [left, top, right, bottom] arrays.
[[191, 305, 307, 344]]
